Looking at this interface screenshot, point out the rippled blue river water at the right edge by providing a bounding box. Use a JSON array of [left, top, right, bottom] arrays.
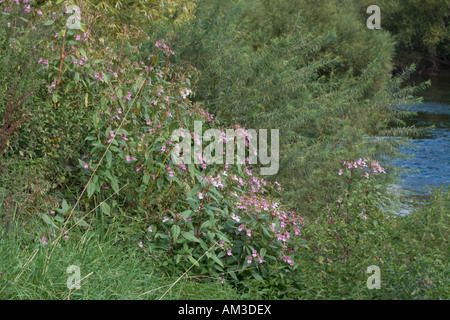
[[394, 77, 450, 212]]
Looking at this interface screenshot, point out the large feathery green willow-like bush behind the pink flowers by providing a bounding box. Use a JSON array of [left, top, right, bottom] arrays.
[[156, 0, 426, 215]]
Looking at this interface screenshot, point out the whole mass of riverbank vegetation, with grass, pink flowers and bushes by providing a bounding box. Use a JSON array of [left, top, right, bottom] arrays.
[[0, 0, 450, 299]]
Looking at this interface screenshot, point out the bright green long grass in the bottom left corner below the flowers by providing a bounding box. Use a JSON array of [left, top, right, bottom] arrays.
[[0, 229, 250, 300]]
